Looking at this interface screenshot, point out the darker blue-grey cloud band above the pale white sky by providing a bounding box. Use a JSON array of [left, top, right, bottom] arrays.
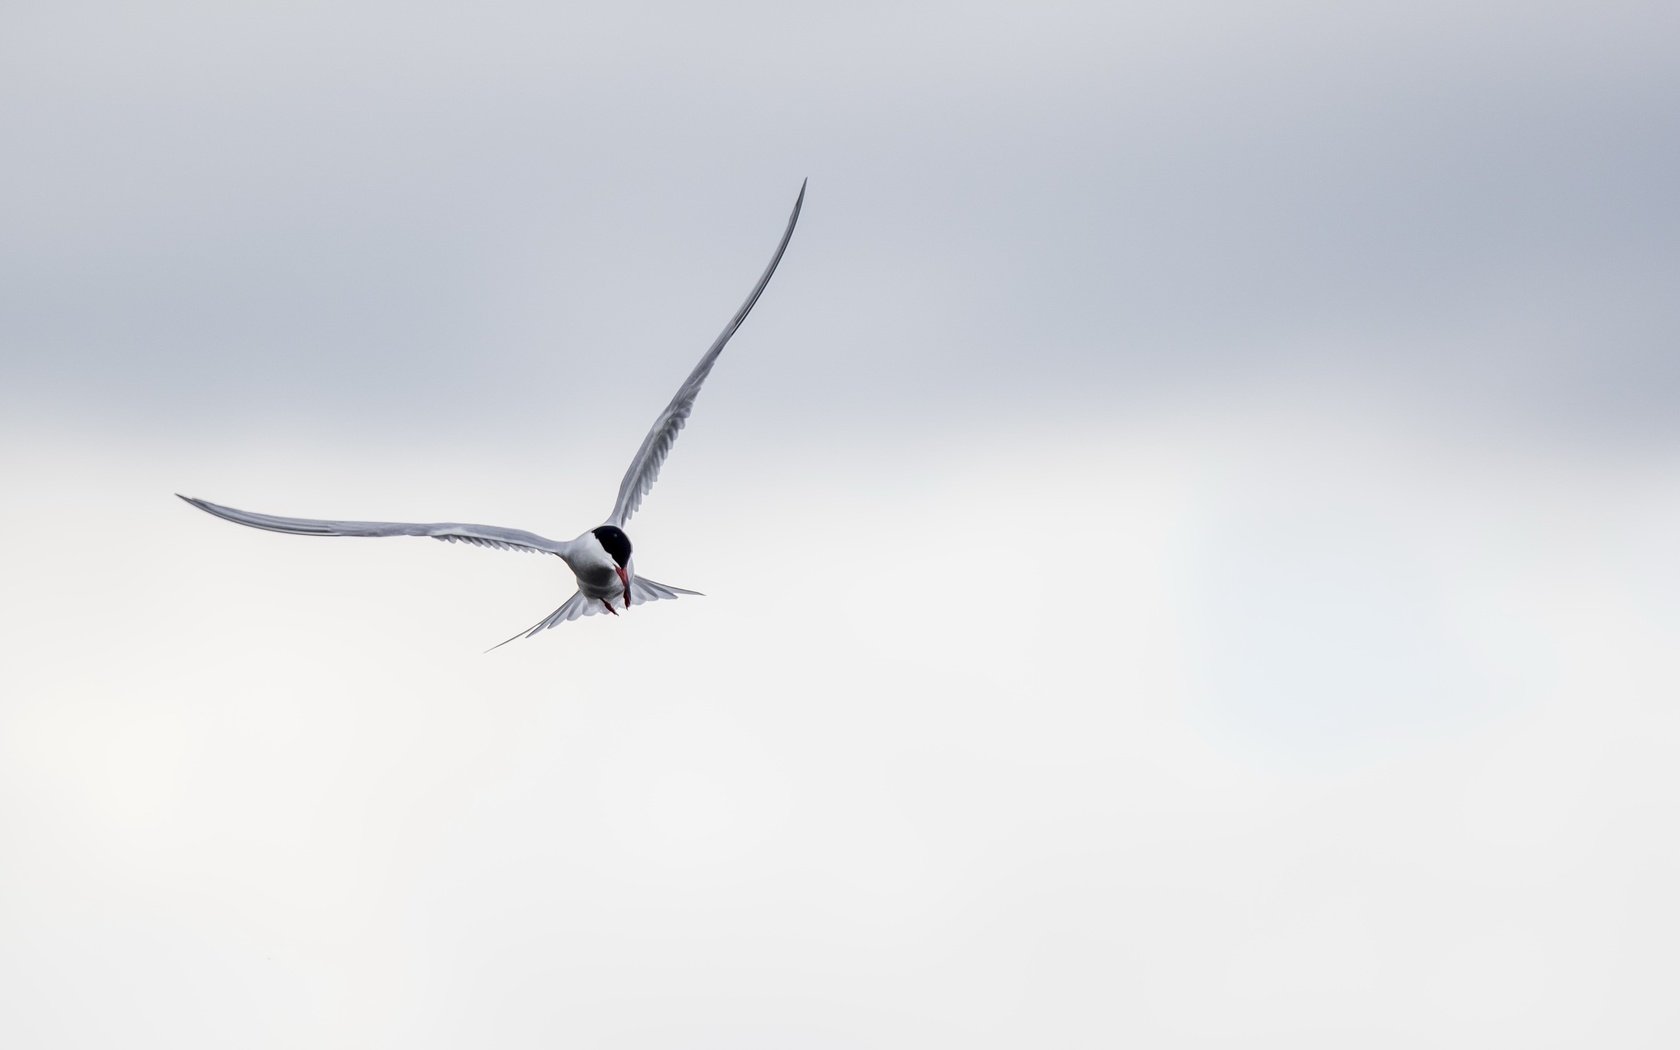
[[0, 3, 1680, 428]]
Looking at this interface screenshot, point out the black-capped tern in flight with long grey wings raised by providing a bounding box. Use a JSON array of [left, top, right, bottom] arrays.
[[176, 183, 805, 648]]
